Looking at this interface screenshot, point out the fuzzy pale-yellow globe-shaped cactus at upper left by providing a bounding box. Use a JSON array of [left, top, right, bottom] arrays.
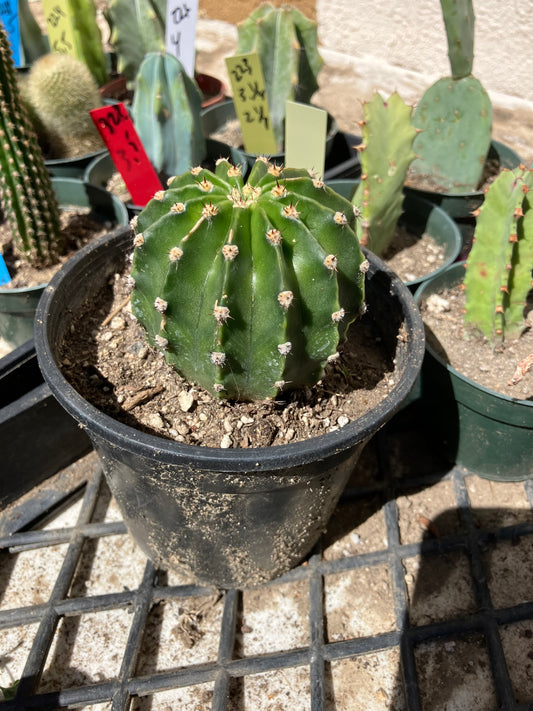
[[23, 54, 104, 158]]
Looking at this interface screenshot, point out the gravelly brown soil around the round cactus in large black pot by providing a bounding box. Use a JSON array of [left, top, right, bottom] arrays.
[[56, 258, 405, 448]]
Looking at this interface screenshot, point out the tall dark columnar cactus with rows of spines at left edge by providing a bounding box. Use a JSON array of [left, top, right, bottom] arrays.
[[0, 23, 63, 266]]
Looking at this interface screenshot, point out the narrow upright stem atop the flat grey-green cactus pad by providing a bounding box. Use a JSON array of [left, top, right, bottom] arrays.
[[440, 0, 474, 79]]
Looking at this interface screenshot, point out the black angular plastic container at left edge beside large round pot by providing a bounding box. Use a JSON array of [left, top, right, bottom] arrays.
[[0, 340, 91, 509]]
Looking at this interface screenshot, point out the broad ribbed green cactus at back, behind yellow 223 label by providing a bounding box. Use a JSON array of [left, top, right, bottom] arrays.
[[237, 3, 324, 149]]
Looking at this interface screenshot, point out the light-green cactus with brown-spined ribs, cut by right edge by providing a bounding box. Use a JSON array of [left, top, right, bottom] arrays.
[[464, 166, 533, 343]]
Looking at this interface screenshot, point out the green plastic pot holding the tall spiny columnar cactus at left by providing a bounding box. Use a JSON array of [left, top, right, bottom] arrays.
[[0, 178, 129, 348]]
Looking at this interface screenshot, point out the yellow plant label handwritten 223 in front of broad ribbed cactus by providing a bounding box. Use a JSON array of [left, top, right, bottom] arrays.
[[226, 53, 277, 155]]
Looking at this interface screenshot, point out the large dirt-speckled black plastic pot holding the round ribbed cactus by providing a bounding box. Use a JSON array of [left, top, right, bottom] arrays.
[[35, 229, 424, 588]]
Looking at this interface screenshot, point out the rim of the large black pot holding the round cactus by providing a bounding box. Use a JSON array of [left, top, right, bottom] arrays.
[[34, 227, 425, 472]]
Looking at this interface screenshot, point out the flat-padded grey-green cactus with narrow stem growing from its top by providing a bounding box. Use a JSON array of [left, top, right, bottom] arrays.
[[412, 0, 492, 193]]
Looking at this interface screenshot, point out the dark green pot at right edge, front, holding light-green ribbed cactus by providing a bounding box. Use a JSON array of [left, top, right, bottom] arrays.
[[415, 262, 533, 481]]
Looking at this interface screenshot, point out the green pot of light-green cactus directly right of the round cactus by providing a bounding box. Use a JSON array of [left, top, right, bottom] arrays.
[[326, 180, 462, 293]]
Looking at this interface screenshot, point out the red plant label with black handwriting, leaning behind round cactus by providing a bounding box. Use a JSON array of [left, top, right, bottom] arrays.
[[89, 102, 163, 207]]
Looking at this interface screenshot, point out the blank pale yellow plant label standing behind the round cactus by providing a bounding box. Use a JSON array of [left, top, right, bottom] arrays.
[[285, 101, 328, 179]]
